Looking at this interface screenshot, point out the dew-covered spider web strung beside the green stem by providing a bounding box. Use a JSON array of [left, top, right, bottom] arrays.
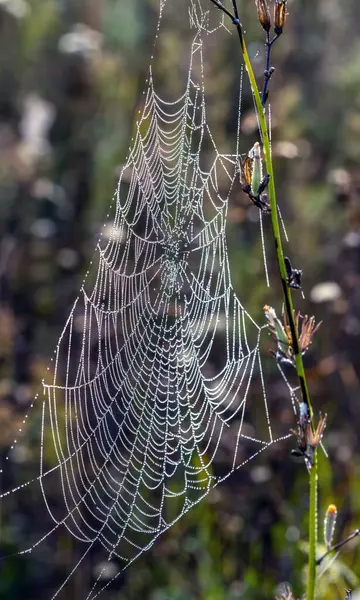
[[3, 2, 292, 598]]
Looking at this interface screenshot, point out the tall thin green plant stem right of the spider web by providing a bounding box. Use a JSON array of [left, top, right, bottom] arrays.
[[211, 0, 318, 600]]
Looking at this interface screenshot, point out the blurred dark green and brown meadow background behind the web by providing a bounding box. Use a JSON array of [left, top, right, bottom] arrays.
[[0, 0, 360, 600]]
